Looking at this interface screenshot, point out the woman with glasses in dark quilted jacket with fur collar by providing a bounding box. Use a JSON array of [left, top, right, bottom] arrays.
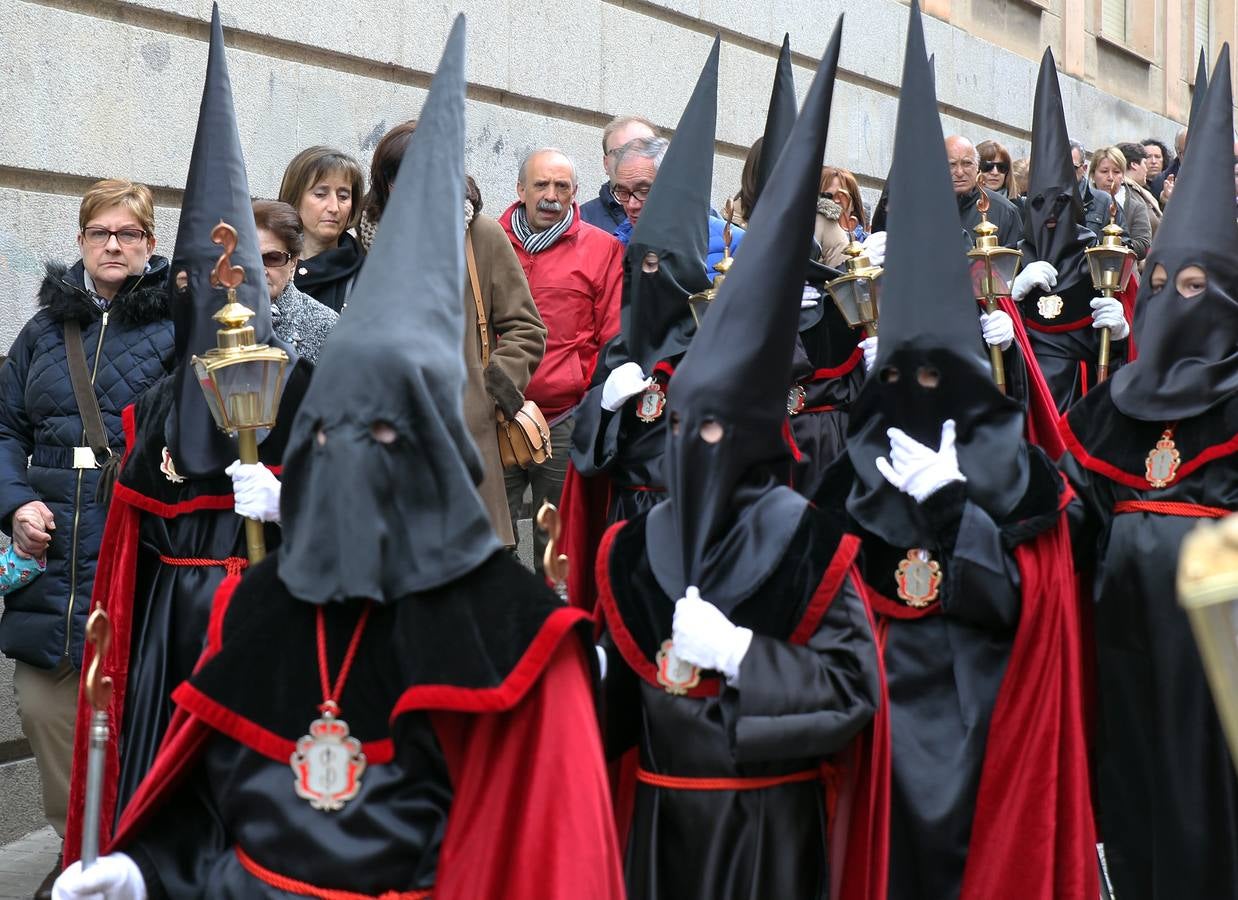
[[0, 181, 173, 884]]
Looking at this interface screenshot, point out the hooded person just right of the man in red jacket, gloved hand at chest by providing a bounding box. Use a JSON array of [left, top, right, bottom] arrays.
[[562, 38, 721, 610]]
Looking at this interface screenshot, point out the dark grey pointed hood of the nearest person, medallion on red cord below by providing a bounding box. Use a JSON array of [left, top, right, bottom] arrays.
[[280, 16, 500, 603]]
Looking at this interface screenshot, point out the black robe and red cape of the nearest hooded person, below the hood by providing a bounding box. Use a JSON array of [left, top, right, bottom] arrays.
[[111, 552, 619, 900]]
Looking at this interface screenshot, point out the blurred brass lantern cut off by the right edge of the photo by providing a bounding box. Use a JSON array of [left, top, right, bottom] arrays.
[[1177, 515, 1238, 766]]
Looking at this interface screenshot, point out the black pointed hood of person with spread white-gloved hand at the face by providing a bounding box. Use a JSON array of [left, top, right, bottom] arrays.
[[847, 0, 1028, 547]]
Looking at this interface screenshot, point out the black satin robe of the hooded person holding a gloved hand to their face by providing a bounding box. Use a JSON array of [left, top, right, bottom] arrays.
[[820, 447, 1061, 900]]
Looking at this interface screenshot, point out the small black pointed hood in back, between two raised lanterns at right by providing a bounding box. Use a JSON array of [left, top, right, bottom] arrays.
[[1023, 48, 1096, 293]]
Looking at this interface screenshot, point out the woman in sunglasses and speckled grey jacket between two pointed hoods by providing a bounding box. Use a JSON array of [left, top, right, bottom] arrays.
[[254, 201, 339, 363]]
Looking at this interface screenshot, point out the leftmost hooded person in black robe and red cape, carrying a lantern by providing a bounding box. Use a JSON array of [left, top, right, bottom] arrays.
[[64, 7, 311, 862]]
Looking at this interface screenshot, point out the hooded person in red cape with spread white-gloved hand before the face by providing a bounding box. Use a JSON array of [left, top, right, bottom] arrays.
[[817, 4, 1099, 900]]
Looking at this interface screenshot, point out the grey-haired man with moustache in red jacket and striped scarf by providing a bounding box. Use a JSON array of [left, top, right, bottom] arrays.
[[499, 149, 623, 572]]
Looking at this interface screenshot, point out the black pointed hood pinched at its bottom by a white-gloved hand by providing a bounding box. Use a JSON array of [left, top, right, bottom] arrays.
[[646, 19, 842, 610]]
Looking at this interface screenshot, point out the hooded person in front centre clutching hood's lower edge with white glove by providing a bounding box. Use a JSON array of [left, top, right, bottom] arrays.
[[598, 22, 880, 900]]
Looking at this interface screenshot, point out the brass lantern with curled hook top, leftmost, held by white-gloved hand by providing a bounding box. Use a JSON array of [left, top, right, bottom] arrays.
[[192, 222, 288, 563]]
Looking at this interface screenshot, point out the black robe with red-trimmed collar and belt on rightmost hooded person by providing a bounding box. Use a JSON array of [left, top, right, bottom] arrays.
[[1061, 384, 1238, 900]]
